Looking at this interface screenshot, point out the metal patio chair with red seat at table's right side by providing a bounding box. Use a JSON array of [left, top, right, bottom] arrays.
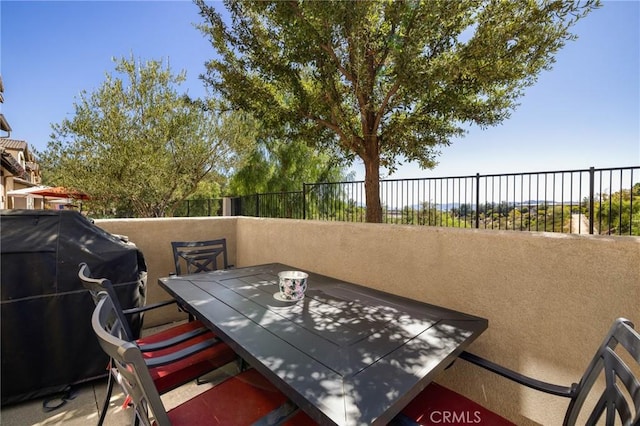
[[392, 318, 640, 426]]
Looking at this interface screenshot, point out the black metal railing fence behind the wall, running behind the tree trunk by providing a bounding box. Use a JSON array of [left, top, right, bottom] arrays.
[[236, 166, 640, 235]]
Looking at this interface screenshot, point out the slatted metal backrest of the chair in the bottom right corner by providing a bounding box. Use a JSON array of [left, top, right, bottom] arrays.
[[564, 318, 640, 425]]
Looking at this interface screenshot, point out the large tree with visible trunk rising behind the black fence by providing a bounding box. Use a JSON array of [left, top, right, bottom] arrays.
[[195, 0, 597, 222]]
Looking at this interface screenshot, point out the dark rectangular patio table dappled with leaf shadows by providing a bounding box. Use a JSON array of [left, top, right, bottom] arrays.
[[159, 263, 488, 425]]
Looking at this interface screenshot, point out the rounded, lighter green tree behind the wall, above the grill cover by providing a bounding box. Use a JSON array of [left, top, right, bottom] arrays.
[[41, 58, 253, 217]]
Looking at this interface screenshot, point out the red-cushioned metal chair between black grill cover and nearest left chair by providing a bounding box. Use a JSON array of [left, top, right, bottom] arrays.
[[78, 263, 238, 425]]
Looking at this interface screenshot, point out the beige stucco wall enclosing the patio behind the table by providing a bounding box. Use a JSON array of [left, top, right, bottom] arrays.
[[98, 218, 640, 425]]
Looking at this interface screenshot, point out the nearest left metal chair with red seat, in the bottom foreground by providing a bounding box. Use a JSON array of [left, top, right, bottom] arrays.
[[91, 293, 314, 426]]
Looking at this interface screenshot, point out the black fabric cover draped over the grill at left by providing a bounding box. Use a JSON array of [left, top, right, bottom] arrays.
[[0, 210, 147, 405]]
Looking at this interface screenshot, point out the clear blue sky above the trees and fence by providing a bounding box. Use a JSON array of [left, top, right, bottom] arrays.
[[0, 0, 640, 179]]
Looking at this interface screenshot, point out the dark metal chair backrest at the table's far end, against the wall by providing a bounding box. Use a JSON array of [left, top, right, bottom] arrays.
[[171, 238, 229, 275]]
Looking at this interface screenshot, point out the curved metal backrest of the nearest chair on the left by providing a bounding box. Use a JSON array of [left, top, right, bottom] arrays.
[[91, 293, 171, 426]]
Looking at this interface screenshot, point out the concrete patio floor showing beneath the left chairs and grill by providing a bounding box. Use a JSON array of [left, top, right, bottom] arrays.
[[0, 324, 239, 426]]
